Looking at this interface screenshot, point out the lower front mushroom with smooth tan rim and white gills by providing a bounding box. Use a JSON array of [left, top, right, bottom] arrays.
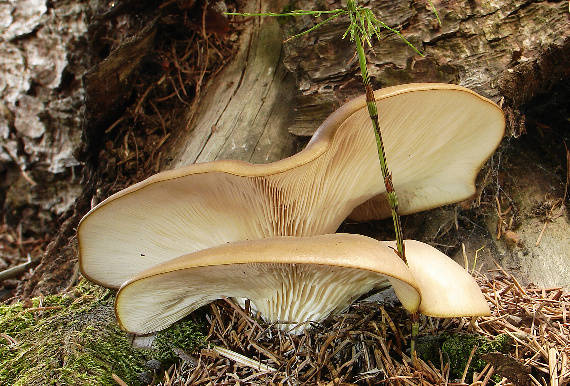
[[115, 234, 420, 334]]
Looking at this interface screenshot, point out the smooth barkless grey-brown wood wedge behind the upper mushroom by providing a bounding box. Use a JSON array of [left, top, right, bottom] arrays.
[[167, 1, 295, 168]]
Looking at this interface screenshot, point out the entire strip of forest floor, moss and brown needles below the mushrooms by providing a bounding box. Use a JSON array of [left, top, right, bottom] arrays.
[[0, 268, 570, 386]]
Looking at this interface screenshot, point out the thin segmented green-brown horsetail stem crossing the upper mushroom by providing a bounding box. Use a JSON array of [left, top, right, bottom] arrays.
[[347, 0, 407, 263]]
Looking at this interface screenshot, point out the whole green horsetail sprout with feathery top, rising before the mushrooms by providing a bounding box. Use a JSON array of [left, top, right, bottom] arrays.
[[226, 0, 441, 360]]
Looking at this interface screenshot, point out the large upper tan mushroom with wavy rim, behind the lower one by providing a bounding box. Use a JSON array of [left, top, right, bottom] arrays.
[[78, 84, 504, 288]]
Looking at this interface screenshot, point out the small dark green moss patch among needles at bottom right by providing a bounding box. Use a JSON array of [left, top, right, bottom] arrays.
[[417, 334, 511, 379]]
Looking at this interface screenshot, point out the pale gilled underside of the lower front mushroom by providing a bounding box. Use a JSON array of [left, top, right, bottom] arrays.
[[116, 263, 417, 334]]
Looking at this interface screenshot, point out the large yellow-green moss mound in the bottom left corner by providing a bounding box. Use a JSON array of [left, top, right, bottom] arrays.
[[0, 282, 146, 385]]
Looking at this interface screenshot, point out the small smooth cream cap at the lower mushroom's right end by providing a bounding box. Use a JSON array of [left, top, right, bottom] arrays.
[[383, 240, 491, 318]]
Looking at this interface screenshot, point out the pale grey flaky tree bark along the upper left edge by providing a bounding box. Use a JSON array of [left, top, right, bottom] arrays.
[[0, 0, 89, 236]]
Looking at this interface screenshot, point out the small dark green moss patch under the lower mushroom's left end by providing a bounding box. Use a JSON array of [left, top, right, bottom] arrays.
[[152, 319, 206, 363]]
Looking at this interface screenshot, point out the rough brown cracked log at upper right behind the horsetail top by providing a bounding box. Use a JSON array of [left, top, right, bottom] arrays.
[[284, 0, 570, 135]]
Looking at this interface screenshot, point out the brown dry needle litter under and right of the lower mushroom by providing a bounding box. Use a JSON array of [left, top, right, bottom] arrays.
[[156, 268, 570, 385]]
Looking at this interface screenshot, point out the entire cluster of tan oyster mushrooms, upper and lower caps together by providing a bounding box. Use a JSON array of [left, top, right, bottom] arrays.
[[78, 84, 505, 334]]
